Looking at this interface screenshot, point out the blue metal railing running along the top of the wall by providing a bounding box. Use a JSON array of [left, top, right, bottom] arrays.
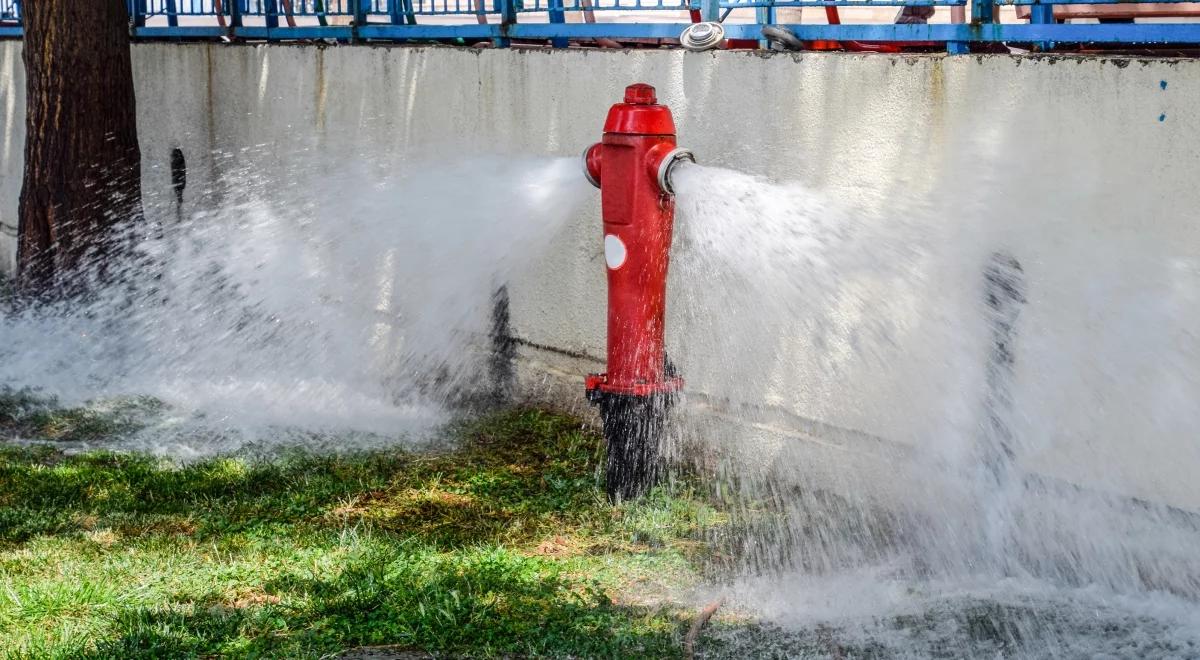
[[0, 0, 1200, 53]]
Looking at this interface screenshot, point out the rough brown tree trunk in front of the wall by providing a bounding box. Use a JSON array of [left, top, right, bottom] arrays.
[[17, 0, 142, 295]]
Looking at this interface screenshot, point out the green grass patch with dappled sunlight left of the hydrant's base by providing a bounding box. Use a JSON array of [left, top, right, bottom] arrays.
[[0, 403, 724, 658]]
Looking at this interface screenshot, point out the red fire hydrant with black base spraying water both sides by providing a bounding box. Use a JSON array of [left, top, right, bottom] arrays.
[[583, 83, 695, 502]]
